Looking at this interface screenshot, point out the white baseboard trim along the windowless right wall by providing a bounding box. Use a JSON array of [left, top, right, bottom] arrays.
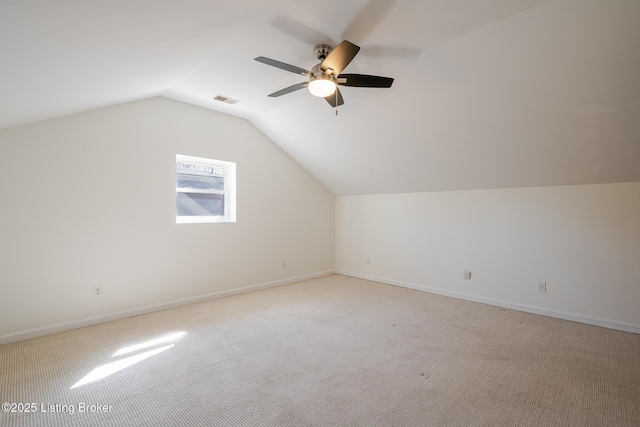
[[335, 270, 640, 334]]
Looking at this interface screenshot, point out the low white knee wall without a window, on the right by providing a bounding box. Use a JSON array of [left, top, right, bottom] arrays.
[[336, 182, 640, 333]]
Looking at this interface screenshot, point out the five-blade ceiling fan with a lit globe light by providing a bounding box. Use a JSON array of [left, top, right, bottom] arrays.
[[255, 40, 393, 107]]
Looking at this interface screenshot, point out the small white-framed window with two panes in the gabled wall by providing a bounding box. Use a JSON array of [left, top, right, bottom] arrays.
[[176, 154, 236, 223]]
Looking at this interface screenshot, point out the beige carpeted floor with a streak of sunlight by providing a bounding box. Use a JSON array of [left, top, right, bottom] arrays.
[[0, 275, 640, 427]]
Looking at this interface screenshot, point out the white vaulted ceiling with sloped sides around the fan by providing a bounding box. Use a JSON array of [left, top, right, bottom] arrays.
[[0, 0, 640, 195]]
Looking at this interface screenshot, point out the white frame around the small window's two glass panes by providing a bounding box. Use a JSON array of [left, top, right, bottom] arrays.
[[174, 154, 236, 224]]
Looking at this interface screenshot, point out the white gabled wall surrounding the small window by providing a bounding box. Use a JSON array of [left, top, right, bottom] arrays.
[[0, 98, 334, 344]]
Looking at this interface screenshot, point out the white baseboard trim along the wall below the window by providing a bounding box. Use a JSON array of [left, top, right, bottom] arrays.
[[0, 270, 335, 345]]
